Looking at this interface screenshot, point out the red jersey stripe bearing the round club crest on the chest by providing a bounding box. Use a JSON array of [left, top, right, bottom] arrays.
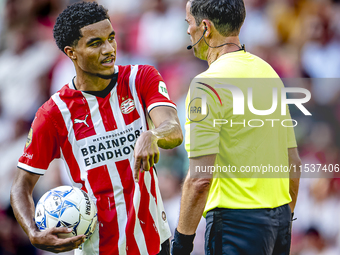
[[117, 66, 140, 125]]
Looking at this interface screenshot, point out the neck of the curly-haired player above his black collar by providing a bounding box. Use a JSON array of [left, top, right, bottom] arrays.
[[74, 74, 111, 91]]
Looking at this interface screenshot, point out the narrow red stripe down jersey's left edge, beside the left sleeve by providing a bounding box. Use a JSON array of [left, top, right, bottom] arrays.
[[53, 102, 87, 192]]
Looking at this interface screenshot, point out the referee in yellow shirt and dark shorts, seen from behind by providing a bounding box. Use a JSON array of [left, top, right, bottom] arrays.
[[172, 0, 300, 255]]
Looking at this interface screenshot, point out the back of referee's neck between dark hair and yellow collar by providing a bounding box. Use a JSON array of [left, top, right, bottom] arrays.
[[207, 36, 241, 66]]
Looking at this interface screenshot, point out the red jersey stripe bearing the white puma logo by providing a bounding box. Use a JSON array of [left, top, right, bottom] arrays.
[[59, 89, 96, 141]]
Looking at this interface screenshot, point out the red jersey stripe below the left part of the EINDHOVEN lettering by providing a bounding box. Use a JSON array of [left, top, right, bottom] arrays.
[[87, 165, 119, 255]]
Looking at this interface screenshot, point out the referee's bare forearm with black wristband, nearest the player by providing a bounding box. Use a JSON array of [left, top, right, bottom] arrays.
[[172, 154, 216, 255]]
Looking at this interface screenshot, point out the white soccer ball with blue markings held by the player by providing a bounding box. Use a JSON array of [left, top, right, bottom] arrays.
[[35, 186, 97, 238]]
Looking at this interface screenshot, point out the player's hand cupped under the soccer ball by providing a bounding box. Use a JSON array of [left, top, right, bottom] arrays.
[[30, 227, 86, 253]]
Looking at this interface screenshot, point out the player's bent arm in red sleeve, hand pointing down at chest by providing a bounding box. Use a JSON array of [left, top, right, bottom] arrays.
[[134, 65, 183, 181]]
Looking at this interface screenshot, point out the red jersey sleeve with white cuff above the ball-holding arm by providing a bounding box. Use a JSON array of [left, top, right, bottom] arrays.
[[18, 108, 60, 175]]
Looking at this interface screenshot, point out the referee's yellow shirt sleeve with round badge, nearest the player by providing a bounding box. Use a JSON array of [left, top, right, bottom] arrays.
[[185, 82, 222, 158]]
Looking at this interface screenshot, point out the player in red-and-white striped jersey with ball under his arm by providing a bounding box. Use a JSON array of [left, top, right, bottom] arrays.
[[11, 2, 183, 255]]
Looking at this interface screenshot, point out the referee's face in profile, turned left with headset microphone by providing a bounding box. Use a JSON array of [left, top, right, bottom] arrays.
[[185, 1, 206, 60]]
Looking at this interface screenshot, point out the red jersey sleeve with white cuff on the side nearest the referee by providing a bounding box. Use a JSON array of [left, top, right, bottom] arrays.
[[139, 65, 176, 112]]
